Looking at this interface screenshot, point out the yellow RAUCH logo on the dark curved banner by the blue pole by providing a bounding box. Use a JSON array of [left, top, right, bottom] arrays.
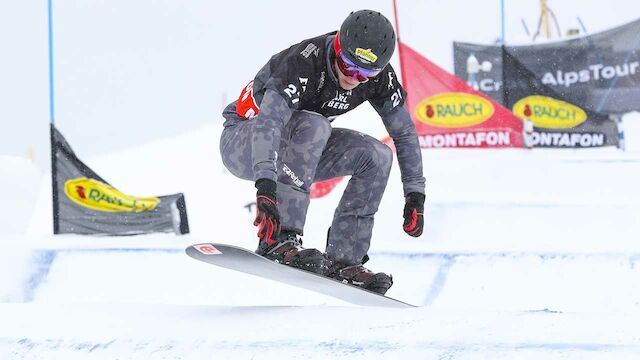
[[64, 178, 160, 212]]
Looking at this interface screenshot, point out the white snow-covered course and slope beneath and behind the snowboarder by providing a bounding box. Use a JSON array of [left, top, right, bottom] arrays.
[[0, 120, 640, 359]]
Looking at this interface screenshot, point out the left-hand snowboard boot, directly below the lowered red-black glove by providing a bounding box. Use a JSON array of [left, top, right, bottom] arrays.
[[256, 230, 324, 273]]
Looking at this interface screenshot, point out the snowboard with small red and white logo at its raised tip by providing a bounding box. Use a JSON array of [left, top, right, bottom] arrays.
[[185, 243, 415, 308]]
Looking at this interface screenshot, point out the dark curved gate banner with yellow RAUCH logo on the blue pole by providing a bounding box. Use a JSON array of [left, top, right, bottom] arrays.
[[51, 124, 189, 235]]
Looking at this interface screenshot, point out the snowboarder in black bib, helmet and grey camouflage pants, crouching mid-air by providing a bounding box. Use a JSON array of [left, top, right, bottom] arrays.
[[220, 10, 425, 294]]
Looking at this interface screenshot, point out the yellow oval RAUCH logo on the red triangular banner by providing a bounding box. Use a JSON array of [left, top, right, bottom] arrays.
[[415, 93, 495, 128]]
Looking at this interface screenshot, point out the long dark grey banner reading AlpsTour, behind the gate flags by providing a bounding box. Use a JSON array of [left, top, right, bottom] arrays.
[[454, 20, 640, 114]]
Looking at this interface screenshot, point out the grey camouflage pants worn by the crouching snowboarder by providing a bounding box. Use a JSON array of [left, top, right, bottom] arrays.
[[220, 111, 393, 264]]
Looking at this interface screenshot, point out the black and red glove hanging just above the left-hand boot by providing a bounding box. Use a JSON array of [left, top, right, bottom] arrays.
[[253, 179, 280, 245]]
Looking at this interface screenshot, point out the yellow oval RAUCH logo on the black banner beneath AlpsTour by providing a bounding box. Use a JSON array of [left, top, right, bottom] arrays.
[[513, 95, 587, 129]]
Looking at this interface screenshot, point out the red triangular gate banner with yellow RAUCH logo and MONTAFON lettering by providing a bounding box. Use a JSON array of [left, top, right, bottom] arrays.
[[398, 42, 524, 148]]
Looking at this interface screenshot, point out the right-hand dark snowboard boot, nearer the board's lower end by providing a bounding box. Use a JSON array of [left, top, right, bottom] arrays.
[[322, 255, 393, 295]]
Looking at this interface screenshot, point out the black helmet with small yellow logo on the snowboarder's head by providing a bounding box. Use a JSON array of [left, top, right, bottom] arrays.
[[336, 10, 396, 69]]
